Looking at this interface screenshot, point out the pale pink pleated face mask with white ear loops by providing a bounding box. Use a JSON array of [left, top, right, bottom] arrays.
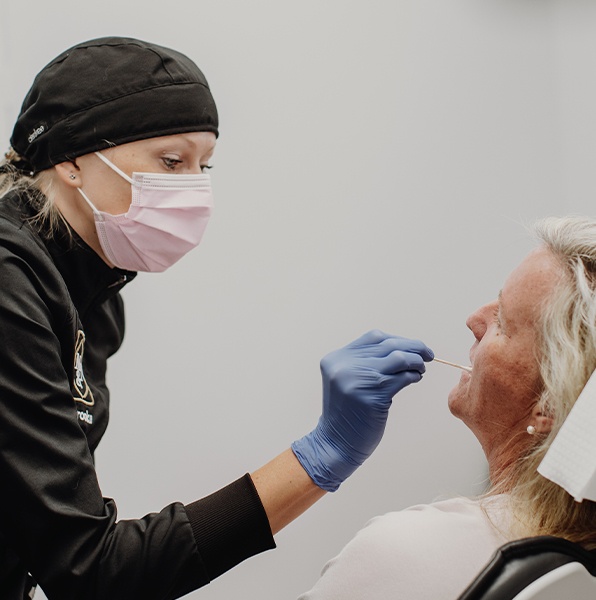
[[77, 152, 213, 273]]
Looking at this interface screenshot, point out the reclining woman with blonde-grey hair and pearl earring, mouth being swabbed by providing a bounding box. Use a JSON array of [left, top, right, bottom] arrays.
[[300, 218, 596, 600]]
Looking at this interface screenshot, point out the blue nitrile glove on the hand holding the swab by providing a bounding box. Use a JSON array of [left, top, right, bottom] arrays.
[[292, 330, 434, 492]]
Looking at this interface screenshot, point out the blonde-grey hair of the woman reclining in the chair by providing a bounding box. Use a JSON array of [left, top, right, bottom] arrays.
[[494, 217, 596, 548]]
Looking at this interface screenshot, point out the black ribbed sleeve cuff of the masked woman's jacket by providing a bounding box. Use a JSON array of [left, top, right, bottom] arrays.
[[184, 474, 275, 580]]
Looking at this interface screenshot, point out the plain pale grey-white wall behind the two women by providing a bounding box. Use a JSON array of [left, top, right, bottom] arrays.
[[0, 0, 596, 600]]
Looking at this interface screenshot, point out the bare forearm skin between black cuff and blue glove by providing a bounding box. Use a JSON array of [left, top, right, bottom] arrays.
[[251, 449, 326, 534]]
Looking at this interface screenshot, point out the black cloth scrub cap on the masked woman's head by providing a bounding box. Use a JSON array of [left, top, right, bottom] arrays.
[[10, 37, 218, 172]]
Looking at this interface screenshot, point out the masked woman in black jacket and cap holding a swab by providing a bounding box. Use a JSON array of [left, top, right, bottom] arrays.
[[0, 37, 433, 600]]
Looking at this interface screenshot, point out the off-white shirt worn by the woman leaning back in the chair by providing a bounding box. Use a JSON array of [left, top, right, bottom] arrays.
[[299, 496, 509, 600]]
